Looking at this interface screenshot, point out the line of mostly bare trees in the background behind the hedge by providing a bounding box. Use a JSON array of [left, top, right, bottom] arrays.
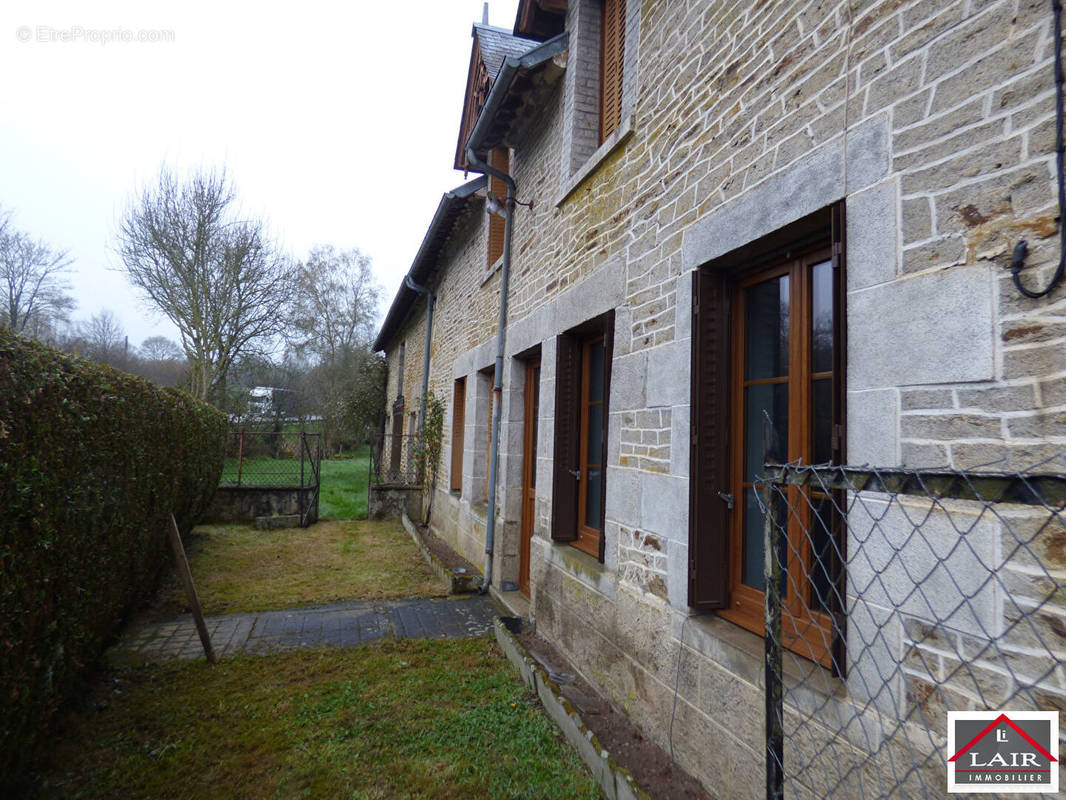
[[0, 167, 385, 452]]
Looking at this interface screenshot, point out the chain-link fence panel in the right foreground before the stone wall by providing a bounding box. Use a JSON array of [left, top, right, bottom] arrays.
[[759, 459, 1066, 799]]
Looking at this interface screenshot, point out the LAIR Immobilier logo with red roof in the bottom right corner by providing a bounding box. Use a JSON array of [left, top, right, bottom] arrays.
[[948, 711, 1059, 795]]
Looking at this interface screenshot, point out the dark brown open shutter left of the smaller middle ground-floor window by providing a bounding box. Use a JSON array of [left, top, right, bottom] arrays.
[[551, 334, 581, 542]]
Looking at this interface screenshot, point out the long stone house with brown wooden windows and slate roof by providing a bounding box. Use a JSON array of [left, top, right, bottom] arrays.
[[375, 0, 1066, 797]]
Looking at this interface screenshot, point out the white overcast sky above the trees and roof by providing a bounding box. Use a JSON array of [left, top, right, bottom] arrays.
[[0, 0, 517, 345]]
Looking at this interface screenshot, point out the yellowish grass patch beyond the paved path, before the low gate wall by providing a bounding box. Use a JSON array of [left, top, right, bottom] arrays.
[[145, 519, 448, 620]]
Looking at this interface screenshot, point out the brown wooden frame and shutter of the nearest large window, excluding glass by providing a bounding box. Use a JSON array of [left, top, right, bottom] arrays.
[[689, 203, 846, 671]]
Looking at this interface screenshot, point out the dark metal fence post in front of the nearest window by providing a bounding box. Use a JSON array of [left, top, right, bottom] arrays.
[[759, 483, 788, 800]]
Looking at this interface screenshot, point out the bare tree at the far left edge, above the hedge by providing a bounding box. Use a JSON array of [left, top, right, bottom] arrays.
[[0, 212, 75, 339]]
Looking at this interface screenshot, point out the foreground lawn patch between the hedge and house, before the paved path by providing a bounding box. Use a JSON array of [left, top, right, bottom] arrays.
[[36, 638, 600, 800]]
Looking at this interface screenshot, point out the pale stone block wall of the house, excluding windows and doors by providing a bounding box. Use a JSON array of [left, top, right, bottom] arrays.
[[379, 0, 1066, 797]]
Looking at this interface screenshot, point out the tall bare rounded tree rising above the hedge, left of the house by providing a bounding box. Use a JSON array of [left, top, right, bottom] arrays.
[[118, 169, 293, 402]]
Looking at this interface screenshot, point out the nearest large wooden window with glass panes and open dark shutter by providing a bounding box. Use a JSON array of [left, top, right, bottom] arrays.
[[689, 208, 844, 666]]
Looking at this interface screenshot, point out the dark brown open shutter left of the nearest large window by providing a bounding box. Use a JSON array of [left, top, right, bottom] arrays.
[[689, 270, 741, 609]]
